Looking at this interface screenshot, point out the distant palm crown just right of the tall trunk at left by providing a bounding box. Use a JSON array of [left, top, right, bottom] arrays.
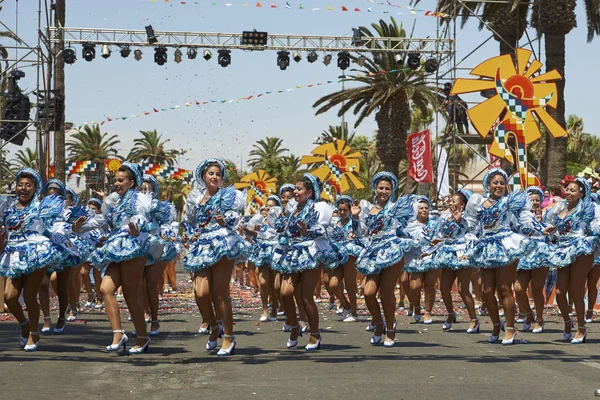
[[66, 124, 123, 162]]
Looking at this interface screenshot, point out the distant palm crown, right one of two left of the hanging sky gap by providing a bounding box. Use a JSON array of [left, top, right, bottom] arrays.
[[127, 129, 182, 167]]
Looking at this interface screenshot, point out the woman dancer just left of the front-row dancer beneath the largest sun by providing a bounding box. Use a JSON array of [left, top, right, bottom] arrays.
[[421, 189, 480, 333]]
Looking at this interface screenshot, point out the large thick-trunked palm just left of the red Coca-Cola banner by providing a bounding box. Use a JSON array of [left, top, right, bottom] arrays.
[[313, 18, 442, 174]]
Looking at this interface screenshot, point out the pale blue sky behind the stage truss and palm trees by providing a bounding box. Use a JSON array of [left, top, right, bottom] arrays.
[[1, 0, 600, 169]]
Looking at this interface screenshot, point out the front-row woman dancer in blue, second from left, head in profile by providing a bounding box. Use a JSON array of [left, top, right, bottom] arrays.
[[84, 161, 152, 354]]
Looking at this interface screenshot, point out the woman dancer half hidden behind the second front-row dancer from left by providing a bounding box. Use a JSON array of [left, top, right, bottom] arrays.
[[136, 175, 177, 336]]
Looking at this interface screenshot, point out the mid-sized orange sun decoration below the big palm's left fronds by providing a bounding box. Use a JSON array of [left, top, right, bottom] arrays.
[[300, 139, 365, 201]]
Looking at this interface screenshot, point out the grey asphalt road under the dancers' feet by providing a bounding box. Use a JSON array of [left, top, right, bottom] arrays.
[[0, 280, 600, 399]]
